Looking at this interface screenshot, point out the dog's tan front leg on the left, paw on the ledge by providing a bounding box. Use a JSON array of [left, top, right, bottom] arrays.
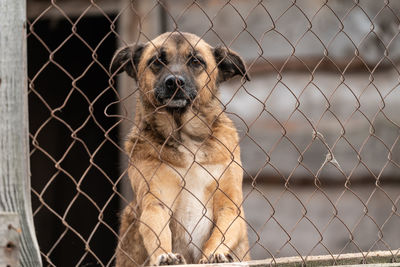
[[139, 193, 185, 265]]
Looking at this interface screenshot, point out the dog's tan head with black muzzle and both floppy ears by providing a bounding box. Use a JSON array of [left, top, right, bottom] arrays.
[[110, 32, 249, 109]]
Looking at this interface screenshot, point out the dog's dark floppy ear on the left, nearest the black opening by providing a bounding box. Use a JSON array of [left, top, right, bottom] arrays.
[[110, 44, 145, 79]]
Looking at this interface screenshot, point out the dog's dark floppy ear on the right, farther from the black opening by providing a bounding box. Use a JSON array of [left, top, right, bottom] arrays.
[[214, 46, 250, 82]]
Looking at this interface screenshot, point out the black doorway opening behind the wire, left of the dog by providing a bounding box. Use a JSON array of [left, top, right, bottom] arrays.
[[28, 16, 119, 266]]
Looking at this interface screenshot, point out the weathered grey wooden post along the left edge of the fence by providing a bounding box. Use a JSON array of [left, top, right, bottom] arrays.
[[0, 0, 42, 267]]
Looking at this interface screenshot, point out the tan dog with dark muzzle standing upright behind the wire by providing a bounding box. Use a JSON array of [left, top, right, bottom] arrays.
[[110, 32, 250, 267]]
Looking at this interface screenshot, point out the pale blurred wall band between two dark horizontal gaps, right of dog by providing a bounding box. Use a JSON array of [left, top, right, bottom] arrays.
[[221, 70, 400, 181]]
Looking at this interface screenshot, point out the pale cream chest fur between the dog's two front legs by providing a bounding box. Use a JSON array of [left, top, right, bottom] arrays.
[[172, 144, 223, 262]]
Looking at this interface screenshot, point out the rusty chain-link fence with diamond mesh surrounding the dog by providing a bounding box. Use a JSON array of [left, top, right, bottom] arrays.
[[27, 0, 400, 266]]
